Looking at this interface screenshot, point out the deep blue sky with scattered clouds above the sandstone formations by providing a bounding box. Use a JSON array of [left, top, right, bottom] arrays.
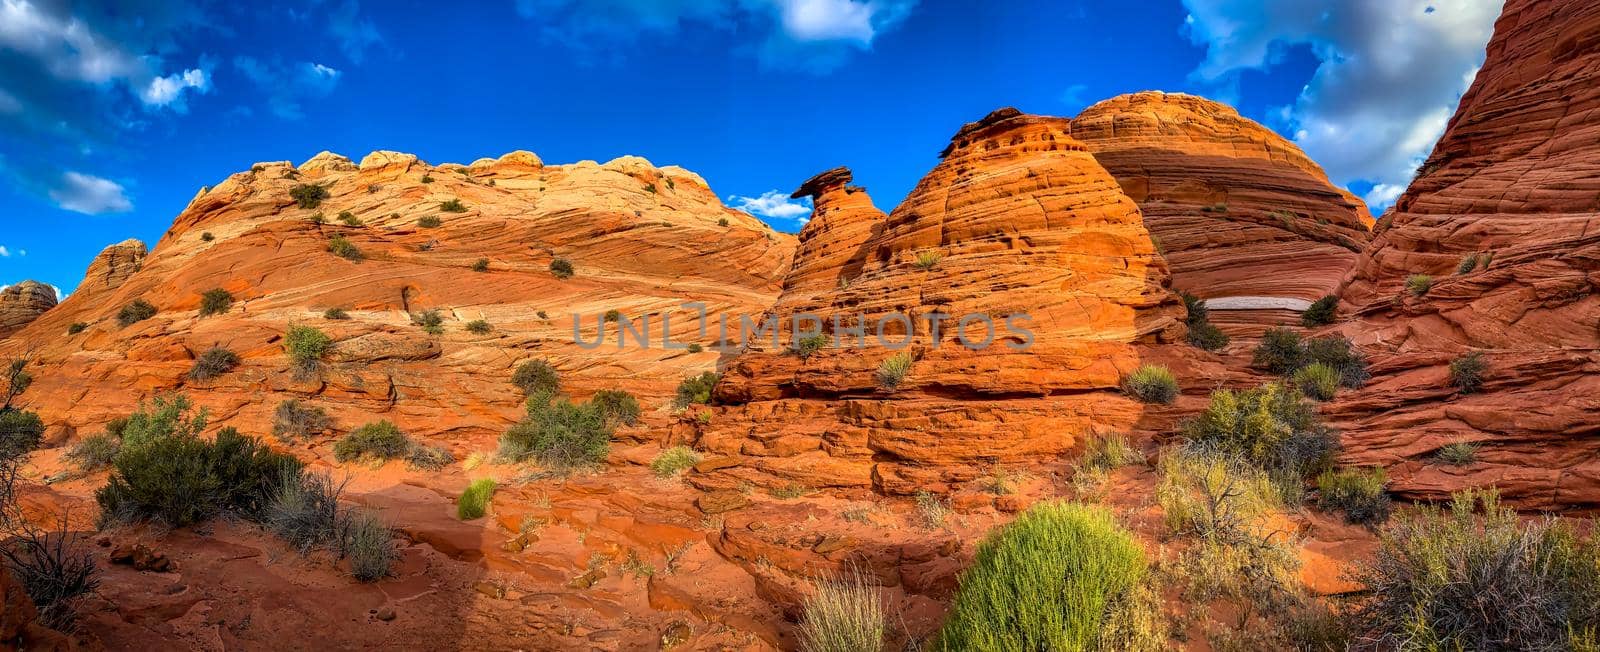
[[0, 0, 1499, 291]]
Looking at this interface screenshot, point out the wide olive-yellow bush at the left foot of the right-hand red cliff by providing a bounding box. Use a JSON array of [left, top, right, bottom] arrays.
[[1182, 384, 1339, 484]]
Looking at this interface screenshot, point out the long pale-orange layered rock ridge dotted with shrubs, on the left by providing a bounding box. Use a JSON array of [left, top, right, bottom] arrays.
[[3, 152, 794, 455]]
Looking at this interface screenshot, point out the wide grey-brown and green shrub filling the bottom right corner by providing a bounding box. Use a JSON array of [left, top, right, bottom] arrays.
[[1352, 491, 1600, 650]]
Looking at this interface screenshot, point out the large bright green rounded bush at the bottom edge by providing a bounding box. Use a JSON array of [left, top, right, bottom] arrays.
[[939, 502, 1146, 650]]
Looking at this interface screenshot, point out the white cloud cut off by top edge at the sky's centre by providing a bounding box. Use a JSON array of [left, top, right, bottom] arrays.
[[517, 0, 917, 72]]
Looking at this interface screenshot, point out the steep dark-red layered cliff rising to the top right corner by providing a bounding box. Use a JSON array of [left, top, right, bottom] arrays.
[[1339, 0, 1600, 507]]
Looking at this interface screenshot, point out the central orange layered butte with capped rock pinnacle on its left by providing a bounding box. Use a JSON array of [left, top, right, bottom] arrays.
[[691, 109, 1184, 494]]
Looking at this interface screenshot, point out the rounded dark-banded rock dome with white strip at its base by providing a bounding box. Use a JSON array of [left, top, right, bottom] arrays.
[[1072, 91, 1371, 332]]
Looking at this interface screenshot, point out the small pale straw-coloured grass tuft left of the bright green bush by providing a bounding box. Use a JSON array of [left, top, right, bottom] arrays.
[[800, 572, 888, 652]]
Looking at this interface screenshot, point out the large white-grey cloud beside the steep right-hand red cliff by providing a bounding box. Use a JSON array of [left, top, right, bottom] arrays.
[[1184, 0, 1501, 213]]
